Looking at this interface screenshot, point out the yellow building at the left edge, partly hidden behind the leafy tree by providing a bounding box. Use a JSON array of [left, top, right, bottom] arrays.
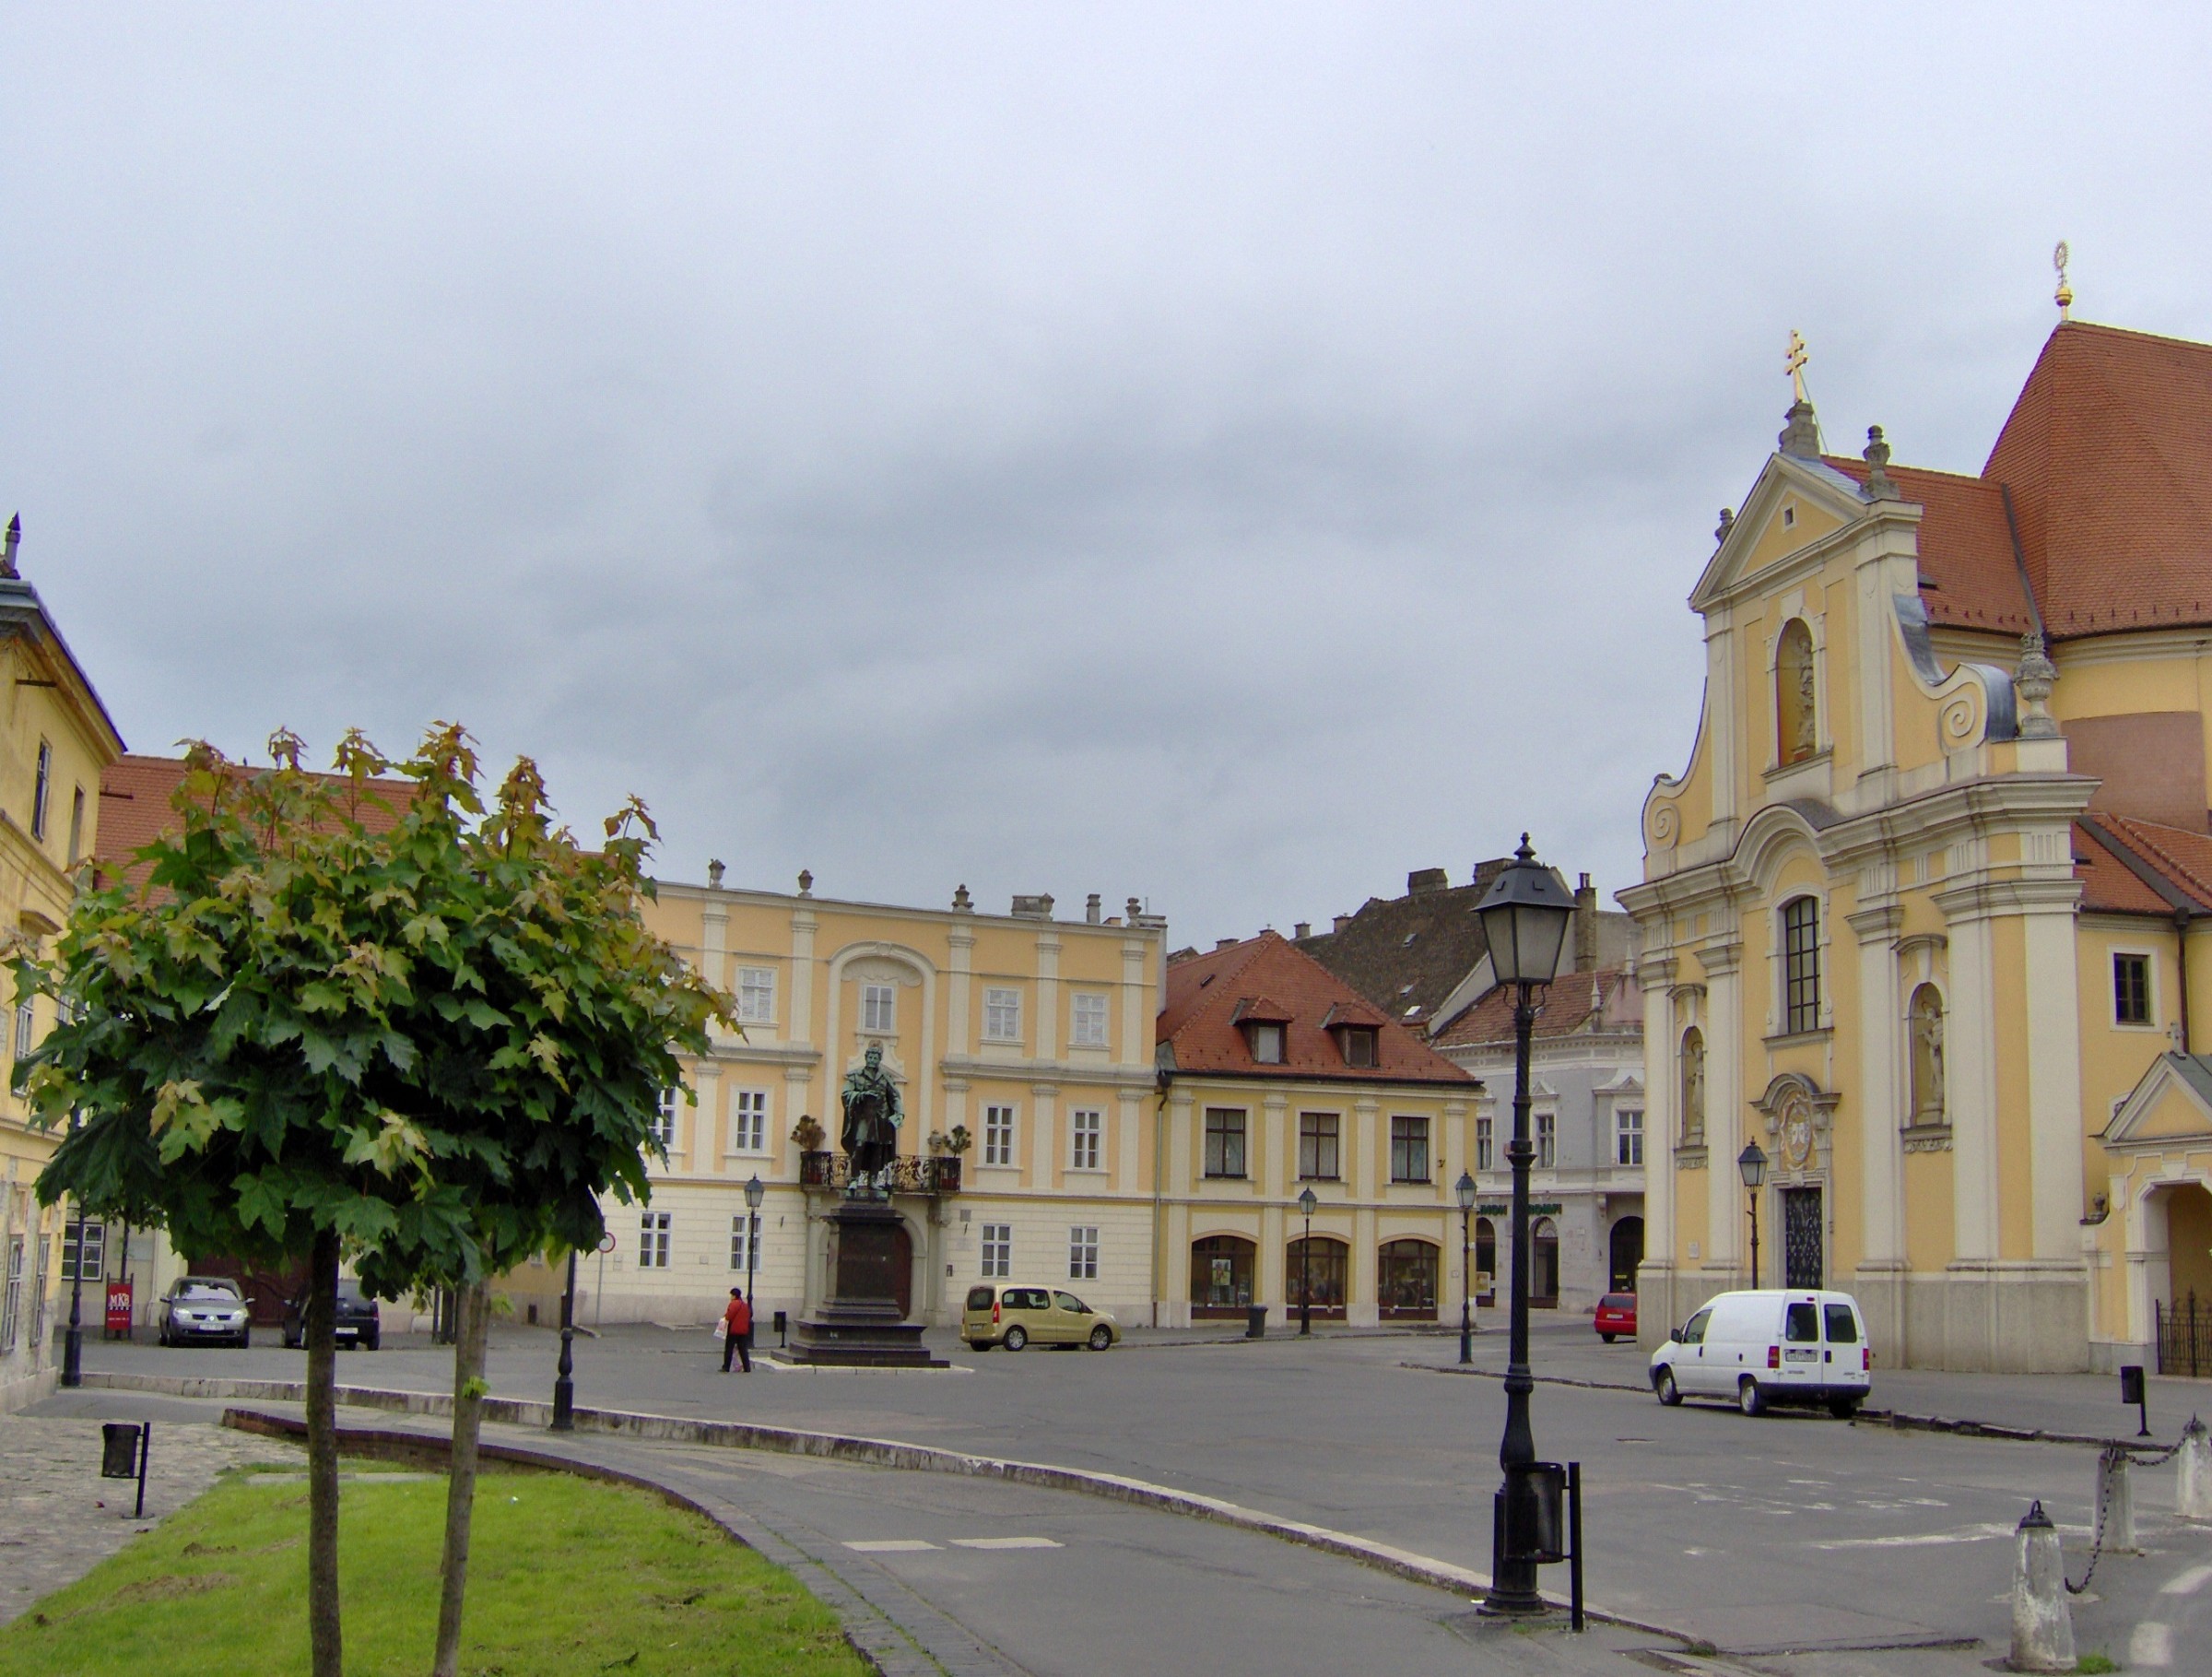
[[0, 525, 124, 1410]]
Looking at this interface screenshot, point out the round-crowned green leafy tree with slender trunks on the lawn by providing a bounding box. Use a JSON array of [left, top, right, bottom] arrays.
[[18, 726, 728, 1677]]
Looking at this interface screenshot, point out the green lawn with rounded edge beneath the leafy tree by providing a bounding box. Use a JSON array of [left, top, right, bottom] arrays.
[[0, 1462, 867, 1677]]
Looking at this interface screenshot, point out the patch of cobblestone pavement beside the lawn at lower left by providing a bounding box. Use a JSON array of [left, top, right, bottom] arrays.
[[0, 1416, 308, 1624]]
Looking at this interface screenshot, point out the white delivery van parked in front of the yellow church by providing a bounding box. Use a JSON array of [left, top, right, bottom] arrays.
[[1650, 1288, 1874, 1421]]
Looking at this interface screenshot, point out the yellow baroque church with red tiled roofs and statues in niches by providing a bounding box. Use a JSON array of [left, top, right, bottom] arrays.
[[1619, 321, 2212, 1369]]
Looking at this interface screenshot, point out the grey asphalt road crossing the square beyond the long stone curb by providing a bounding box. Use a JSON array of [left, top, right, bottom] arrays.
[[60, 1328, 2212, 1671]]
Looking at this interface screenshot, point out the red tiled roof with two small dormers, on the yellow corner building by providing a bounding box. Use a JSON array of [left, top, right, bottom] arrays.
[[1155, 931, 1476, 1086]]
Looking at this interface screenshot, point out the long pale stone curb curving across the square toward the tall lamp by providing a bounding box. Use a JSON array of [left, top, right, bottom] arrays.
[[84, 1374, 1688, 1642]]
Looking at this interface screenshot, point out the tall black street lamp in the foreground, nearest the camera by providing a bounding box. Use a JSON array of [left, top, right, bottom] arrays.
[[1476, 832, 1575, 1612]]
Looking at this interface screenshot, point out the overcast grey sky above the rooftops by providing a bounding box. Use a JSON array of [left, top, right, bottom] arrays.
[[0, 0, 2212, 942]]
